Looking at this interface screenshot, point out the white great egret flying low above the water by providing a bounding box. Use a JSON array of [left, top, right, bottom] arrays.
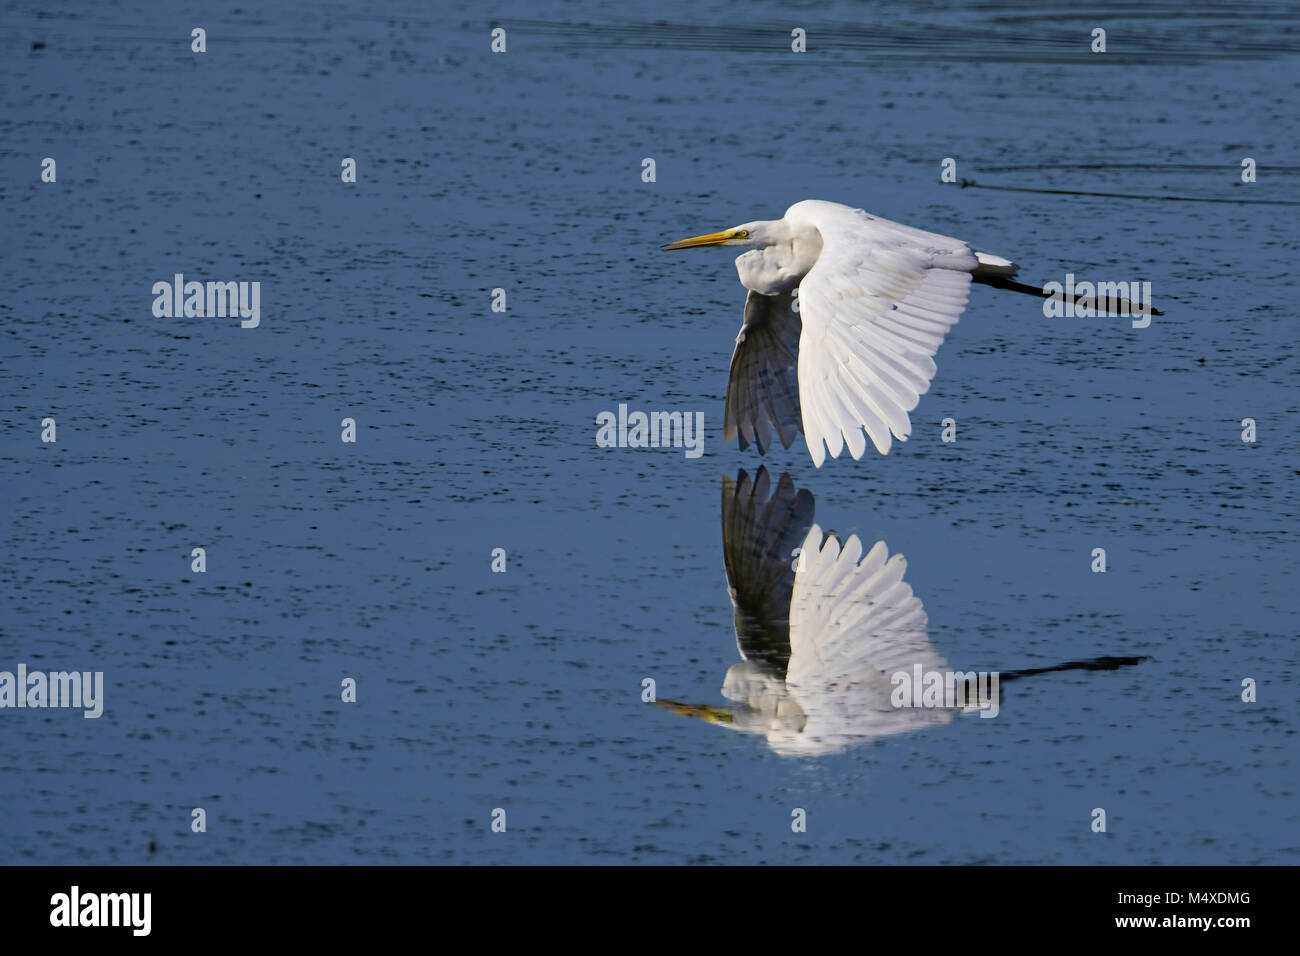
[[664, 199, 1160, 467]]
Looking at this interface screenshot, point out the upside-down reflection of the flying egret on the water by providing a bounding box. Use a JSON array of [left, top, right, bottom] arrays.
[[658, 468, 1140, 754]]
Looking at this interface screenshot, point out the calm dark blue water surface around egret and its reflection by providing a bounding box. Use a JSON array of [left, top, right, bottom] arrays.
[[0, 0, 1300, 864]]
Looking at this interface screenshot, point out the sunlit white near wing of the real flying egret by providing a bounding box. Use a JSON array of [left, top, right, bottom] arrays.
[[785, 199, 979, 467]]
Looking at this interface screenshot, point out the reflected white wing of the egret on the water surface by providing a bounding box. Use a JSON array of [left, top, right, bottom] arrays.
[[768, 524, 954, 753]]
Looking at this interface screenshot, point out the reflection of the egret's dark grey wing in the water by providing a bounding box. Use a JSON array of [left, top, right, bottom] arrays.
[[723, 468, 815, 680]]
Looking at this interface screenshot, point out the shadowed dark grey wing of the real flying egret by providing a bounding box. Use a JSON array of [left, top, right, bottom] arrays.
[[723, 291, 803, 454]]
